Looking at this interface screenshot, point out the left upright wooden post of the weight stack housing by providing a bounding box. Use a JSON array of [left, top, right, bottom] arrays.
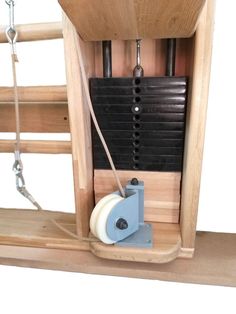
[[63, 15, 95, 236]]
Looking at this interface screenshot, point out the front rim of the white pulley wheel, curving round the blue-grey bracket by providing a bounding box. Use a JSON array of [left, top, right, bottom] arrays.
[[95, 195, 124, 244]]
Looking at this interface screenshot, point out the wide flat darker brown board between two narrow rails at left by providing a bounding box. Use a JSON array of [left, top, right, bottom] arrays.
[[0, 102, 70, 133]]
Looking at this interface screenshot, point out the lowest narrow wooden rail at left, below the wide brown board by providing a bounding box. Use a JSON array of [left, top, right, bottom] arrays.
[[0, 140, 71, 154]]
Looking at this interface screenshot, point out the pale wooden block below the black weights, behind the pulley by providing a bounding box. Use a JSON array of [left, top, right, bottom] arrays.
[[94, 170, 181, 223]]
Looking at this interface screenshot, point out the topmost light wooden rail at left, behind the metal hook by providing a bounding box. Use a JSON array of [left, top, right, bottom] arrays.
[[0, 22, 62, 43]]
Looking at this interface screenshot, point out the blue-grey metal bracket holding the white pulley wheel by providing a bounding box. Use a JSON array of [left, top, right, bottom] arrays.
[[106, 181, 152, 248]]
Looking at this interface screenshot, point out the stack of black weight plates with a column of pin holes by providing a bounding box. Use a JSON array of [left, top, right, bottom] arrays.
[[90, 77, 187, 171]]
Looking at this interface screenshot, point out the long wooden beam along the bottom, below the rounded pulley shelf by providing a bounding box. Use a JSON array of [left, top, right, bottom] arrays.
[[0, 232, 236, 287]]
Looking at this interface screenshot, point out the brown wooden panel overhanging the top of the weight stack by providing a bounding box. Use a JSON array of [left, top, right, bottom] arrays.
[[59, 0, 205, 41]]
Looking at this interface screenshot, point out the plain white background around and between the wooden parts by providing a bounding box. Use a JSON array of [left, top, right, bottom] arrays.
[[0, 0, 236, 314]]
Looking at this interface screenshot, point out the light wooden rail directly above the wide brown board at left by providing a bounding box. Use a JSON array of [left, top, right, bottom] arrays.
[[0, 85, 67, 102]]
